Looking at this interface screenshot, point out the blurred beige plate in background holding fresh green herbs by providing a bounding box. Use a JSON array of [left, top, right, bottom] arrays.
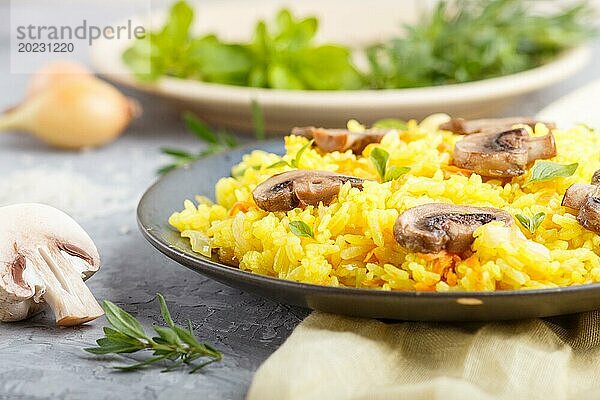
[[92, 0, 591, 134]]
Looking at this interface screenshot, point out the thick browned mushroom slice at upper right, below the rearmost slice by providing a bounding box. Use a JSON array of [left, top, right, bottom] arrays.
[[453, 129, 556, 178]]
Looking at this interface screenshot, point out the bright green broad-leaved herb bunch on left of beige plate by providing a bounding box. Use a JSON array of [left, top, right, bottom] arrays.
[[123, 1, 364, 90]]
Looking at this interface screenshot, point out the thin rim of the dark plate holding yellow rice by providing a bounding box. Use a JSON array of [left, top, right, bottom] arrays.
[[136, 139, 600, 300]]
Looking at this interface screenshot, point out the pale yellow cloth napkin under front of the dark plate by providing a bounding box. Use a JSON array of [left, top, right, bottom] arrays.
[[247, 312, 600, 400]]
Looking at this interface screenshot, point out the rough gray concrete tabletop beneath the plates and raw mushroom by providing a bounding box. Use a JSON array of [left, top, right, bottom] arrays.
[[0, 2, 600, 400]]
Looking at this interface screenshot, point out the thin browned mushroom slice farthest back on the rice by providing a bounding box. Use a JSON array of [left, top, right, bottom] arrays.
[[439, 117, 556, 135]]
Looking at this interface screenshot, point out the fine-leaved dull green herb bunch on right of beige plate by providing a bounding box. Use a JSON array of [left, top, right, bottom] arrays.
[[367, 0, 595, 88]]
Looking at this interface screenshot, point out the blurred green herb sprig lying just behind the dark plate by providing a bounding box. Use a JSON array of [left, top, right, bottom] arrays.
[[157, 100, 266, 175]]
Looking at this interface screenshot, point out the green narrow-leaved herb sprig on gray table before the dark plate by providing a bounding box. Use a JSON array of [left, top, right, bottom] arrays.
[[84, 293, 223, 374]]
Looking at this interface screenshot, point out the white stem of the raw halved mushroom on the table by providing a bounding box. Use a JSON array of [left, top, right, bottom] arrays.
[[28, 247, 104, 326]]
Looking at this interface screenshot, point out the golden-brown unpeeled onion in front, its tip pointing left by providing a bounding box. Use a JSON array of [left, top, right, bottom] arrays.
[[0, 78, 137, 150]]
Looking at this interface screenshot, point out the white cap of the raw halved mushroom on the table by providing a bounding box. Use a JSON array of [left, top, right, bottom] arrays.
[[0, 204, 100, 320]]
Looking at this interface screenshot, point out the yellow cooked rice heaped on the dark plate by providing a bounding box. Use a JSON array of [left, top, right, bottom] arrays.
[[169, 120, 600, 292]]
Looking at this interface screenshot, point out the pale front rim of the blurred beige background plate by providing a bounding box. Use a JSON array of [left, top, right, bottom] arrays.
[[91, 42, 592, 110]]
